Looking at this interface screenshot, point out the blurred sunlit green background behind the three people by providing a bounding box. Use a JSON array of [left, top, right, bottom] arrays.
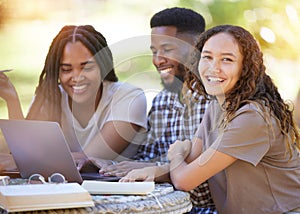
[[0, 0, 300, 118]]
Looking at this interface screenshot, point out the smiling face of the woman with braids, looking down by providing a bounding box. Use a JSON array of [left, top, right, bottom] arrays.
[[59, 41, 101, 105]]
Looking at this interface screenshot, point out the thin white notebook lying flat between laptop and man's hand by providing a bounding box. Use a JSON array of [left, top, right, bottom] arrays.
[[81, 180, 155, 195]]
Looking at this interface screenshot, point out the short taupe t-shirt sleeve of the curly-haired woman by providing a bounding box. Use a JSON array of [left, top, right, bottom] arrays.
[[212, 108, 270, 166]]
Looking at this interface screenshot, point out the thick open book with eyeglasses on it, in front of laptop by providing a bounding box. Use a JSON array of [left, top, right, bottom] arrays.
[[0, 183, 94, 212]]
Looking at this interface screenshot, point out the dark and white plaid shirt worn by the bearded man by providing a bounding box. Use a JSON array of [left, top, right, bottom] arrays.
[[134, 90, 216, 213]]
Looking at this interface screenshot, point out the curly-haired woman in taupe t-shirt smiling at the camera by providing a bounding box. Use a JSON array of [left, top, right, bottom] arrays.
[[122, 25, 300, 214]]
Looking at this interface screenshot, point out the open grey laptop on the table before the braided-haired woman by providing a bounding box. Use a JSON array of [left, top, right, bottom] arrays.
[[0, 119, 119, 184]]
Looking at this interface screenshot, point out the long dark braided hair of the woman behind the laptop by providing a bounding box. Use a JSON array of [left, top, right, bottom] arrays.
[[26, 25, 118, 123]]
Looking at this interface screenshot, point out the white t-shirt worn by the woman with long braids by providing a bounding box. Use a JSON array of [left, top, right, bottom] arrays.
[[61, 81, 147, 159]]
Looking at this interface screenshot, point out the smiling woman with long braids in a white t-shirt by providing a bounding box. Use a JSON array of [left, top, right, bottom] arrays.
[[1, 25, 147, 168]]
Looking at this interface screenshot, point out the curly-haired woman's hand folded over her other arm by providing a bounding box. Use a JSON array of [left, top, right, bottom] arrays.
[[168, 140, 192, 161]]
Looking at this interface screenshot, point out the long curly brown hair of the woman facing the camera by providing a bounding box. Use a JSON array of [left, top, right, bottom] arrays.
[[186, 25, 300, 155]]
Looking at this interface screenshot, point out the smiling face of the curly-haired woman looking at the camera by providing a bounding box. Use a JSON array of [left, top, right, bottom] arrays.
[[199, 33, 243, 104]]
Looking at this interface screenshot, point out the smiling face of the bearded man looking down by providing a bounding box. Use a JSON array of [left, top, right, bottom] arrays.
[[150, 26, 191, 91]]
